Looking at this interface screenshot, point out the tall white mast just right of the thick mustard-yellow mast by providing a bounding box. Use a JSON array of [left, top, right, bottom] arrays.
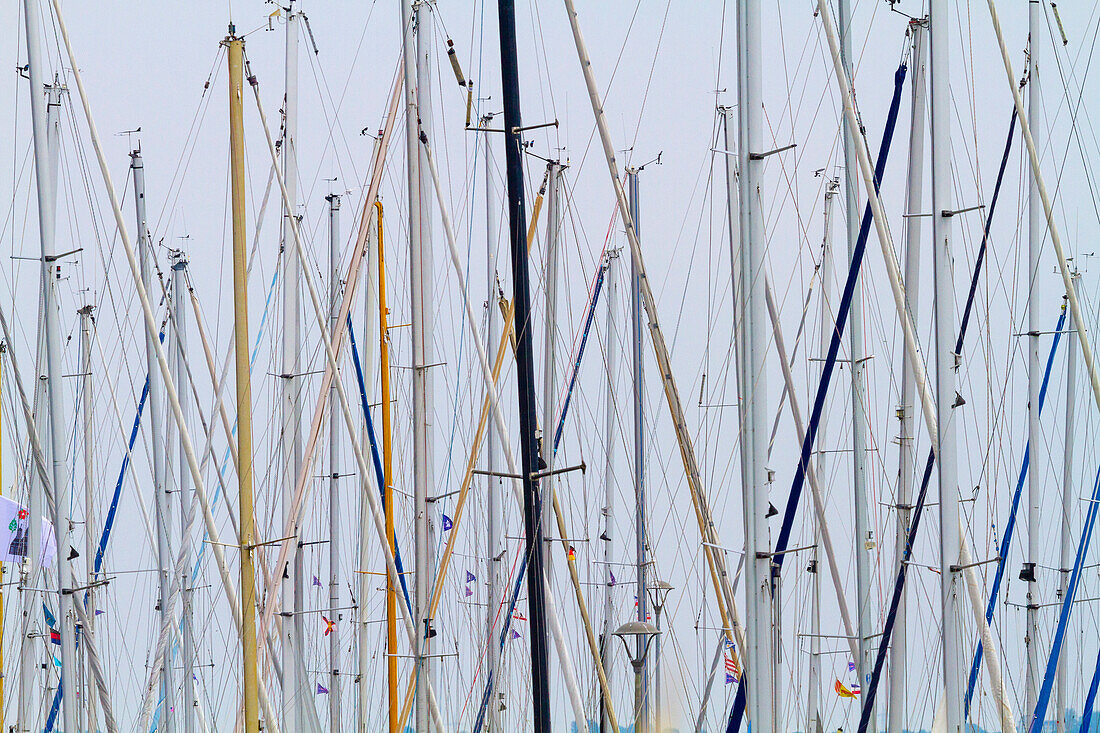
[[279, 0, 312, 730]]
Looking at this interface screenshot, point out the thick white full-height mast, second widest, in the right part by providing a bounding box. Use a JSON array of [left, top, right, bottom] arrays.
[[928, 0, 963, 733]]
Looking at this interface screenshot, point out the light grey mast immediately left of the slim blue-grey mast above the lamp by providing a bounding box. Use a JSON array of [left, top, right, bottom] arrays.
[[600, 250, 619, 733]]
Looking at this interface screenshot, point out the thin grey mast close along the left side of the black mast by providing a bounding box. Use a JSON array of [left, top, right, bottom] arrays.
[[481, 114, 505, 733]]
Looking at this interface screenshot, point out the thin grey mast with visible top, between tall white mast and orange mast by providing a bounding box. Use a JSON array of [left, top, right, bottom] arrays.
[[325, 194, 343, 731]]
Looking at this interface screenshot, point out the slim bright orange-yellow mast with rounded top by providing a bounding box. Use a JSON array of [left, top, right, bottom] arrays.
[[376, 195, 400, 733]]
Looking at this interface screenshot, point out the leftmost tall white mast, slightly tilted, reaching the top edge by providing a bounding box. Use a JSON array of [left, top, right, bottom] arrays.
[[23, 0, 77, 731]]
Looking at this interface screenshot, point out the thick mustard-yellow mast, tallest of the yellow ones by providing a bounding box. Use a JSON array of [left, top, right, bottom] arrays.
[[226, 28, 260, 733]]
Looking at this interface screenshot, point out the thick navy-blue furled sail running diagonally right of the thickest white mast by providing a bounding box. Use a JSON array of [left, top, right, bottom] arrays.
[[726, 62, 906, 733]]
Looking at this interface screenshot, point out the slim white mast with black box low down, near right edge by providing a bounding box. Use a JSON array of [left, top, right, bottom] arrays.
[[1020, 2, 1042, 721]]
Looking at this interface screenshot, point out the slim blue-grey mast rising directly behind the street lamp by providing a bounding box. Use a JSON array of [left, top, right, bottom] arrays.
[[626, 168, 649, 733]]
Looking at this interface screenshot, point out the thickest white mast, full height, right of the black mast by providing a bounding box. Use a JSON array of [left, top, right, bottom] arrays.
[[737, 0, 776, 733]]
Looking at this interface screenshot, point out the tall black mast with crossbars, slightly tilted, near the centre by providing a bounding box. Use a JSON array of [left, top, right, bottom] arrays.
[[497, 0, 550, 733]]
